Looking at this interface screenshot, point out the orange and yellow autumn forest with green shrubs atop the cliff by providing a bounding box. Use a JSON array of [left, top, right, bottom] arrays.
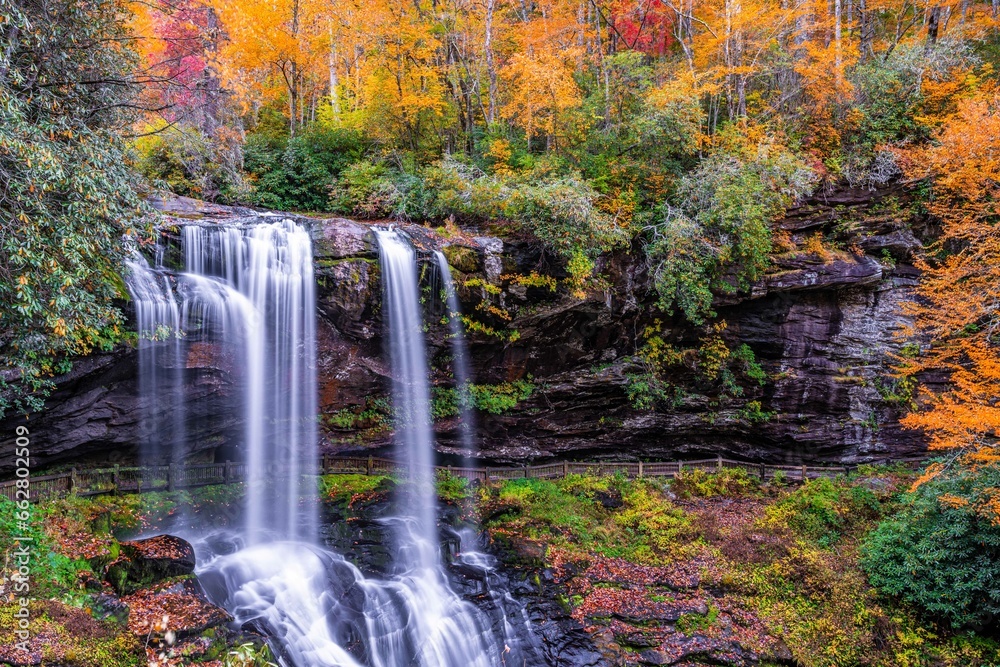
[[121, 0, 997, 323]]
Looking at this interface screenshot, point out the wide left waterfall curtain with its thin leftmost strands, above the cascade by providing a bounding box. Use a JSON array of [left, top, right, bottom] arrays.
[[128, 220, 318, 542]]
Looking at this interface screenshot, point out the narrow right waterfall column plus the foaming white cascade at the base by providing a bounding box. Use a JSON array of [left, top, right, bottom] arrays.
[[199, 229, 543, 667]]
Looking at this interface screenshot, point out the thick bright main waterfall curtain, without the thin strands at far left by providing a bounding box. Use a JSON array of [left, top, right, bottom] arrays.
[[183, 220, 318, 542]]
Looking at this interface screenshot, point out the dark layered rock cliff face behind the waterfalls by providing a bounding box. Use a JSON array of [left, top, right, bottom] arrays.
[[0, 190, 924, 469]]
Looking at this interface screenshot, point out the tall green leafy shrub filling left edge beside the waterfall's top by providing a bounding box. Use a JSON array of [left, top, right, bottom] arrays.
[[0, 0, 151, 416]]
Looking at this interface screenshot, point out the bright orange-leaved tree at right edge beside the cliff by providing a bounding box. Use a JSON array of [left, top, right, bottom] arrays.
[[898, 86, 1000, 463]]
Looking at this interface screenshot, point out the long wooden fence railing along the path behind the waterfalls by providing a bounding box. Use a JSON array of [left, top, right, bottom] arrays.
[[0, 456, 924, 501]]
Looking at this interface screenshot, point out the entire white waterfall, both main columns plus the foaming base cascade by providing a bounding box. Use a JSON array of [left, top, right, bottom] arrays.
[[129, 220, 540, 667]]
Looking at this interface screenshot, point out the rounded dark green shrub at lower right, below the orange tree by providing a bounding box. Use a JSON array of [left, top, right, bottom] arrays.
[[861, 465, 1000, 627]]
